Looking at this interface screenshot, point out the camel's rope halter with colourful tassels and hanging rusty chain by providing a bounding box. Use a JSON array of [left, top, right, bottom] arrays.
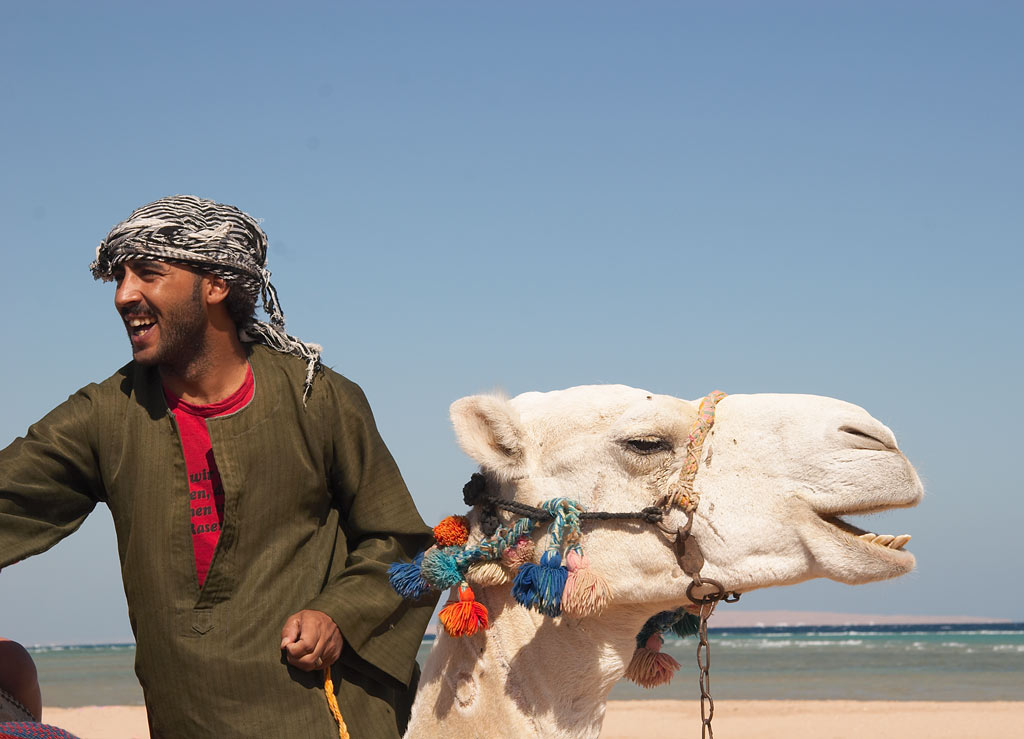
[[388, 390, 739, 736]]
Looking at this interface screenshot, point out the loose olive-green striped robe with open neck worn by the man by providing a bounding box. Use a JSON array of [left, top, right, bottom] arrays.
[[0, 345, 433, 739]]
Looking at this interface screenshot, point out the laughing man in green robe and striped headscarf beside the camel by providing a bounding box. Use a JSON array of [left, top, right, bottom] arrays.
[[0, 195, 433, 739]]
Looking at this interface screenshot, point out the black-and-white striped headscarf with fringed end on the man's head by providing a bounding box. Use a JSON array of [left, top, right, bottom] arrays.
[[95, 195, 323, 400]]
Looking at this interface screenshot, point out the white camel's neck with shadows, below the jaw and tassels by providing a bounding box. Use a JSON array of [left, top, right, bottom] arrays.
[[407, 585, 650, 739]]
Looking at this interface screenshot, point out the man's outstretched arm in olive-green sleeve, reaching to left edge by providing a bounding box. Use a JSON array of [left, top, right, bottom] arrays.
[[0, 386, 102, 567]]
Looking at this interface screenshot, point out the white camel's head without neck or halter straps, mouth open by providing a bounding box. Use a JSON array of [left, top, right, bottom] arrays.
[[451, 386, 923, 612]]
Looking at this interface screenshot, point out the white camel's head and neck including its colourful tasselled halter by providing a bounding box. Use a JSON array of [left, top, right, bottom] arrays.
[[401, 385, 922, 739]]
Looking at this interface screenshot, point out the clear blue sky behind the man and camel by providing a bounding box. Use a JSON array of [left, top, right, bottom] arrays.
[[0, 0, 1024, 644]]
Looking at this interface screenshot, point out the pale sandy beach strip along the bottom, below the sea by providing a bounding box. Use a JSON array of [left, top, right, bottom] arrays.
[[36, 700, 1024, 739]]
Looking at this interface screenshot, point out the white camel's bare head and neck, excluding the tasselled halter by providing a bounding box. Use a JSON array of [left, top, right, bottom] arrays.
[[397, 386, 923, 739]]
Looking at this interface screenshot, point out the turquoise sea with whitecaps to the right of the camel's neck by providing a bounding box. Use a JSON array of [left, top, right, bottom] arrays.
[[611, 623, 1024, 701]]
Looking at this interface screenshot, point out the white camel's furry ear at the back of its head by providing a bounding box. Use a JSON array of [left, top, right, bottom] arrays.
[[449, 395, 525, 479]]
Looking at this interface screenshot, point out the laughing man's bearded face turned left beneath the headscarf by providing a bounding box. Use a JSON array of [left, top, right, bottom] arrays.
[[114, 259, 208, 366]]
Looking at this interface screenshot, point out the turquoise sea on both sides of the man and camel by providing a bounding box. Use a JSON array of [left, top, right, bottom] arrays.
[[30, 623, 1024, 707]]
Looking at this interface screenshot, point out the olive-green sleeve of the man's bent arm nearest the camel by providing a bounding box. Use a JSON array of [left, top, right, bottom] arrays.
[[292, 373, 436, 684]]
